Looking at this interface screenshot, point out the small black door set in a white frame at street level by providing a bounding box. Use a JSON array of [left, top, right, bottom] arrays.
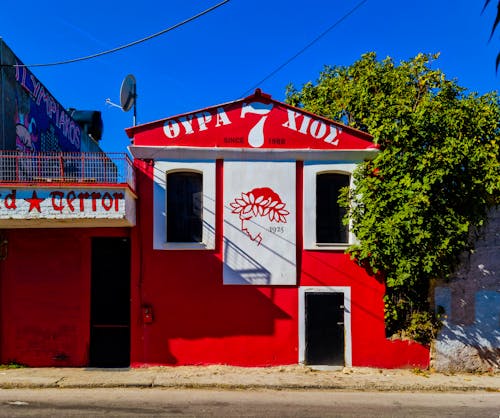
[[305, 292, 344, 366]]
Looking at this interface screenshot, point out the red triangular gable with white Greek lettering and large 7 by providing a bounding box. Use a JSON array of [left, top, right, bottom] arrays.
[[126, 90, 376, 150]]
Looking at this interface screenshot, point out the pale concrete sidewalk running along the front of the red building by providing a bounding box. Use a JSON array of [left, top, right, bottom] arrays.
[[0, 366, 500, 393]]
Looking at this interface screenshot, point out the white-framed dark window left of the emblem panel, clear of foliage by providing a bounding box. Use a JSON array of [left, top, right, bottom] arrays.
[[153, 161, 215, 250]]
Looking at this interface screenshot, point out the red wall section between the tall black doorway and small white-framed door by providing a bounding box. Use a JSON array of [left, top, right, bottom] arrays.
[[131, 162, 298, 366]]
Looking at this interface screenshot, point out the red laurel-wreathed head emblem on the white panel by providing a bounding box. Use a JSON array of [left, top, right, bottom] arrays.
[[230, 187, 290, 245]]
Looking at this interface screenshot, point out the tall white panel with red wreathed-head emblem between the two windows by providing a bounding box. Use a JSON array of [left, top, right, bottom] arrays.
[[223, 161, 297, 285]]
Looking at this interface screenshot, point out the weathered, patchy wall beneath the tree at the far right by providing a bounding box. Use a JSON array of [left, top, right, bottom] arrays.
[[432, 208, 500, 372]]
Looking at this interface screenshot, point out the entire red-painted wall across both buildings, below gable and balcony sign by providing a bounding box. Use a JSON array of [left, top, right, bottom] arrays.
[[0, 158, 429, 367]]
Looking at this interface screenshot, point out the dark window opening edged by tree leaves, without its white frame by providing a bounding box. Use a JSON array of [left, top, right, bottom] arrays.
[[316, 173, 349, 244]]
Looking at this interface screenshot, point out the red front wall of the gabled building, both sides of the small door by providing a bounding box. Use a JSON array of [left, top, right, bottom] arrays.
[[131, 161, 429, 367]]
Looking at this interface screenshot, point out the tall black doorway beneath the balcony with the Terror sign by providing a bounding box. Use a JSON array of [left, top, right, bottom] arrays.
[[89, 238, 130, 367]]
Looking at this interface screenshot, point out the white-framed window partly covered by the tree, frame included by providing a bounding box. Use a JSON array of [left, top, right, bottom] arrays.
[[304, 162, 356, 249]]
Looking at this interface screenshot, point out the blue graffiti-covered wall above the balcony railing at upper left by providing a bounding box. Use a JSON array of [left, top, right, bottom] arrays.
[[15, 66, 82, 152]]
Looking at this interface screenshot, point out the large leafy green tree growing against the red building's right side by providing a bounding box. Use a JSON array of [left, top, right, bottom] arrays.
[[287, 53, 500, 343]]
